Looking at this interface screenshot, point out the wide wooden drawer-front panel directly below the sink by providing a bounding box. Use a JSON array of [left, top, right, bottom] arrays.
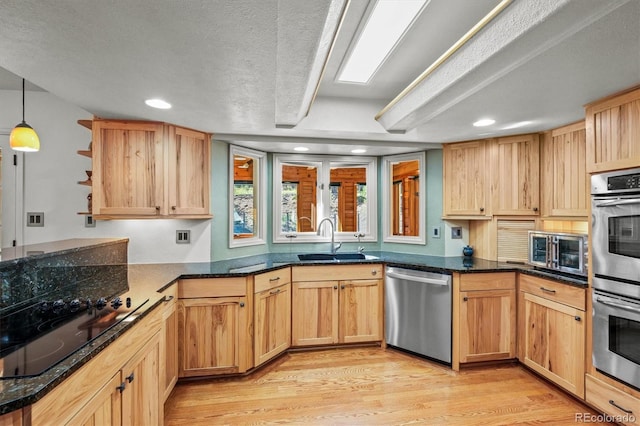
[[291, 264, 382, 281]]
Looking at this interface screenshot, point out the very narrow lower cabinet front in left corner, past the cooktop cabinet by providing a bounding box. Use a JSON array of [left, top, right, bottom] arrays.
[[160, 284, 178, 404]]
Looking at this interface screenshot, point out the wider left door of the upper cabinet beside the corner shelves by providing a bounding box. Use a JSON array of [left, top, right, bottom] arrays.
[[91, 120, 166, 218]]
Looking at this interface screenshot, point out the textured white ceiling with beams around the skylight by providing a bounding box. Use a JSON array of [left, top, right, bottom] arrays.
[[0, 0, 640, 154]]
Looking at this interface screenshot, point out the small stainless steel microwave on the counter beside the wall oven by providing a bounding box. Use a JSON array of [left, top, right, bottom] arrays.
[[528, 231, 588, 276]]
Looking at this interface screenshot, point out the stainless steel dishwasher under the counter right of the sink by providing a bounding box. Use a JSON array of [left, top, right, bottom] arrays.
[[385, 267, 452, 364]]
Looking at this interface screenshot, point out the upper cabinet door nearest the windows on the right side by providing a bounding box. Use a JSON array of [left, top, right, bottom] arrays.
[[443, 140, 491, 217]]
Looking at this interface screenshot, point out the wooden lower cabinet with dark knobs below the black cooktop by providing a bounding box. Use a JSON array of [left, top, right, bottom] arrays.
[[31, 309, 164, 425]]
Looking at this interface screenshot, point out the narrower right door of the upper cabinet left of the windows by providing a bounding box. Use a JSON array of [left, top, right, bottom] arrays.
[[167, 126, 211, 215]]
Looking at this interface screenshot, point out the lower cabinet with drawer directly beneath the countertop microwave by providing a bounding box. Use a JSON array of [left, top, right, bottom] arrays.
[[518, 274, 586, 398]]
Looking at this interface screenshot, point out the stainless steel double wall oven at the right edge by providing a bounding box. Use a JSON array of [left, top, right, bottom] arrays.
[[591, 169, 640, 389]]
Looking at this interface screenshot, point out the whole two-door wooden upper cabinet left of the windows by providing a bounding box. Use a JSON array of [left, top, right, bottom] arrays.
[[92, 120, 211, 219]]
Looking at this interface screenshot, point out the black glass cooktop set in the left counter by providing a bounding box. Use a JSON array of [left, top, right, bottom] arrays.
[[0, 297, 148, 379]]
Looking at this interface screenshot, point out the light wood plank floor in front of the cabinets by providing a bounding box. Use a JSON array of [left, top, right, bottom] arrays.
[[165, 347, 608, 426]]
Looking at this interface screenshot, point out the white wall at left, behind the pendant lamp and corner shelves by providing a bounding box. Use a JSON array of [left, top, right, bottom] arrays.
[[0, 90, 211, 263]]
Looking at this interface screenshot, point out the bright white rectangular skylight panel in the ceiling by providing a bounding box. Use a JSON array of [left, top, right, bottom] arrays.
[[338, 0, 427, 84]]
